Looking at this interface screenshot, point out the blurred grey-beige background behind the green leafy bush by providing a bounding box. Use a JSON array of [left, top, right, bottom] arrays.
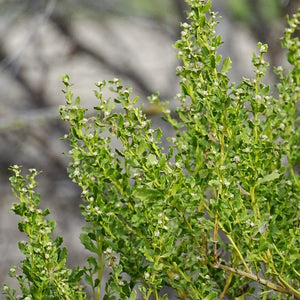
[[0, 0, 300, 299]]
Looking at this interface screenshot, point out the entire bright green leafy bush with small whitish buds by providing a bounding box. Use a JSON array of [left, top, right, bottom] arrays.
[[4, 0, 300, 300]]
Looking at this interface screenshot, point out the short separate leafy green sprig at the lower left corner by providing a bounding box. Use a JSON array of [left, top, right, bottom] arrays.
[[3, 166, 86, 300]]
